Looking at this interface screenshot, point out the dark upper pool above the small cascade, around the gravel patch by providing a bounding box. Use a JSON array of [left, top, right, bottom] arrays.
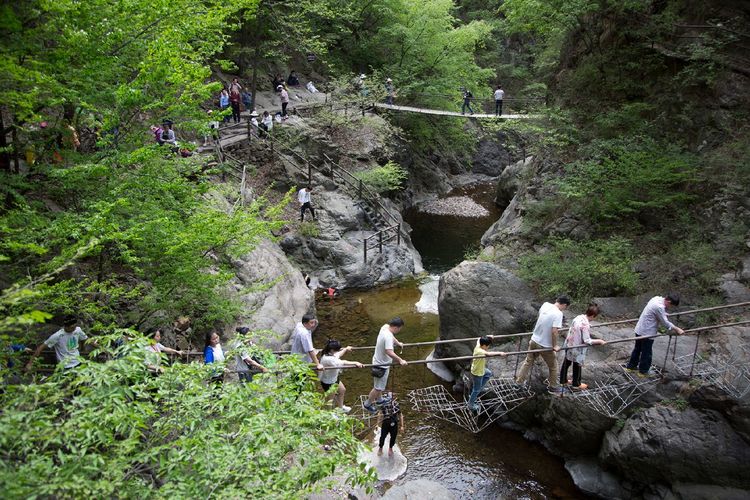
[[404, 182, 503, 273]]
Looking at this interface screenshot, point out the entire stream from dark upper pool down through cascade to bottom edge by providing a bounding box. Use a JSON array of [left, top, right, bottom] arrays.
[[314, 184, 584, 499]]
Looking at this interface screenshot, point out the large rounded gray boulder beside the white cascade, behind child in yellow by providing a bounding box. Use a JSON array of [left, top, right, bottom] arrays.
[[436, 261, 537, 358]]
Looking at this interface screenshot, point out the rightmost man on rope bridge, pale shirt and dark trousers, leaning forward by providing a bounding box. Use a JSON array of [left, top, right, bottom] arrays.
[[625, 293, 685, 378]]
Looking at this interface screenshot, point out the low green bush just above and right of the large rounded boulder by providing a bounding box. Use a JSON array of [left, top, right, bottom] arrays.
[[520, 237, 638, 302]]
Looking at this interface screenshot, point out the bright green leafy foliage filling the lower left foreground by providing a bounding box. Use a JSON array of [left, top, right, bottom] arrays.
[[0, 332, 374, 499]]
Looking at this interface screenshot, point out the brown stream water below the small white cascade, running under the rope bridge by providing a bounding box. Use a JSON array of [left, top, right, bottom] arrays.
[[313, 281, 582, 499]]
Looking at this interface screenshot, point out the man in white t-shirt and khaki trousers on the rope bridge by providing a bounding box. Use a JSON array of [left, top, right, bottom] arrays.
[[516, 295, 570, 394]]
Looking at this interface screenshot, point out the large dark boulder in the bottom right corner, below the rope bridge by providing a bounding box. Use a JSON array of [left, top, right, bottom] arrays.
[[599, 406, 750, 489]]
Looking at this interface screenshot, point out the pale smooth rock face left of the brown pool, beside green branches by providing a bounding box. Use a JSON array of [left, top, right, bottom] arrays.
[[228, 240, 315, 348]]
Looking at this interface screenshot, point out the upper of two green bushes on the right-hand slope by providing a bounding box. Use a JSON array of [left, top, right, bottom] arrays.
[[559, 137, 697, 223]]
